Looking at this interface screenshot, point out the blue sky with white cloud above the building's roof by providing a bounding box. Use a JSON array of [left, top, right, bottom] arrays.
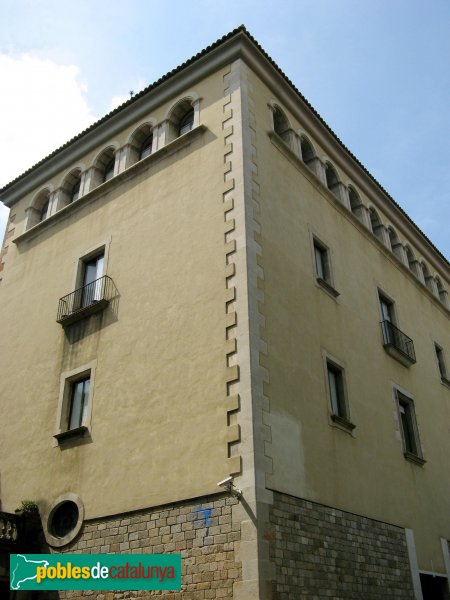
[[0, 0, 450, 258]]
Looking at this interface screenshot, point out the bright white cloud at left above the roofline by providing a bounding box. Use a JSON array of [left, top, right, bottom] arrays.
[[0, 54, 95, 245]]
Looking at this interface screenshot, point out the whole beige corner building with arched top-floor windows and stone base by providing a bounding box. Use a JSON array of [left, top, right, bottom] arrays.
[[0, 27, 450, 600]]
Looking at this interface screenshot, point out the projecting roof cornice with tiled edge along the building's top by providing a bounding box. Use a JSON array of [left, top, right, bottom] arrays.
[[0, 25, 450, 280]]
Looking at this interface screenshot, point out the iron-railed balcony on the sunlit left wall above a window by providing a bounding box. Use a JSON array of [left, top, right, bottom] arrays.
[[56, 275, 115, 327]]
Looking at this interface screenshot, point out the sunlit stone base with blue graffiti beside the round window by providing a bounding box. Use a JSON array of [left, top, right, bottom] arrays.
[[53, 496, 242, 600]]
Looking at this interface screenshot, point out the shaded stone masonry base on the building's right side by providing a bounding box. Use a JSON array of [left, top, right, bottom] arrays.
[[266, 492, 415, 600]]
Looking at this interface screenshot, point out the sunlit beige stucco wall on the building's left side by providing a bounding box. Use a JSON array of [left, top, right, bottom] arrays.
[[0, 74, 232, 518]]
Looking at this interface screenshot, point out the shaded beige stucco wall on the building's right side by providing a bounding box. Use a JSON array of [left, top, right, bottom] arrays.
[[252, 68, 450, 572]]
